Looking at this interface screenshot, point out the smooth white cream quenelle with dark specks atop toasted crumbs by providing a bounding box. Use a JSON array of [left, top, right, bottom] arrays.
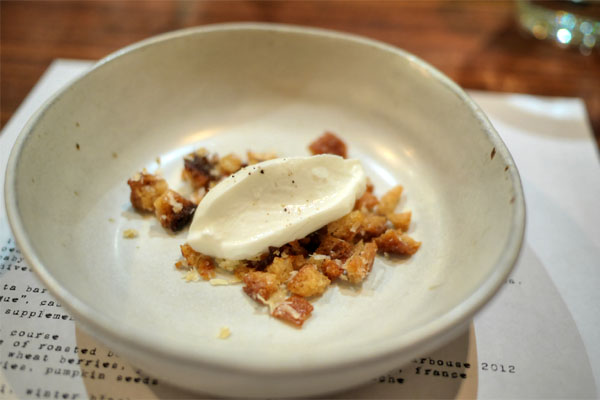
[[187, 154, 366, 260]]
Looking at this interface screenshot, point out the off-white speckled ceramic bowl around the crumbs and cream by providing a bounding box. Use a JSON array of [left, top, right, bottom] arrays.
[[6, 24, 524, 396]]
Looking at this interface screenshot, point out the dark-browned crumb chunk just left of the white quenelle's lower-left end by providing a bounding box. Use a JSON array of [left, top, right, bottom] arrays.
[[154, 189, 196, 232]]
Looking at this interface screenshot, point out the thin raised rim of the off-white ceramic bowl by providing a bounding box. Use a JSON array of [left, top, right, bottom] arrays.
[[4, 22, 525, 376]]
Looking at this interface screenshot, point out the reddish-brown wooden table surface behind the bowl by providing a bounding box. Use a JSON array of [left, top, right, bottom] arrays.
[[0, 0, 600, 144]]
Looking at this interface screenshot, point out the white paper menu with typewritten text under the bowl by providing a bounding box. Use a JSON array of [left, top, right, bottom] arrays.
[[0, 60, 600, 399]]
